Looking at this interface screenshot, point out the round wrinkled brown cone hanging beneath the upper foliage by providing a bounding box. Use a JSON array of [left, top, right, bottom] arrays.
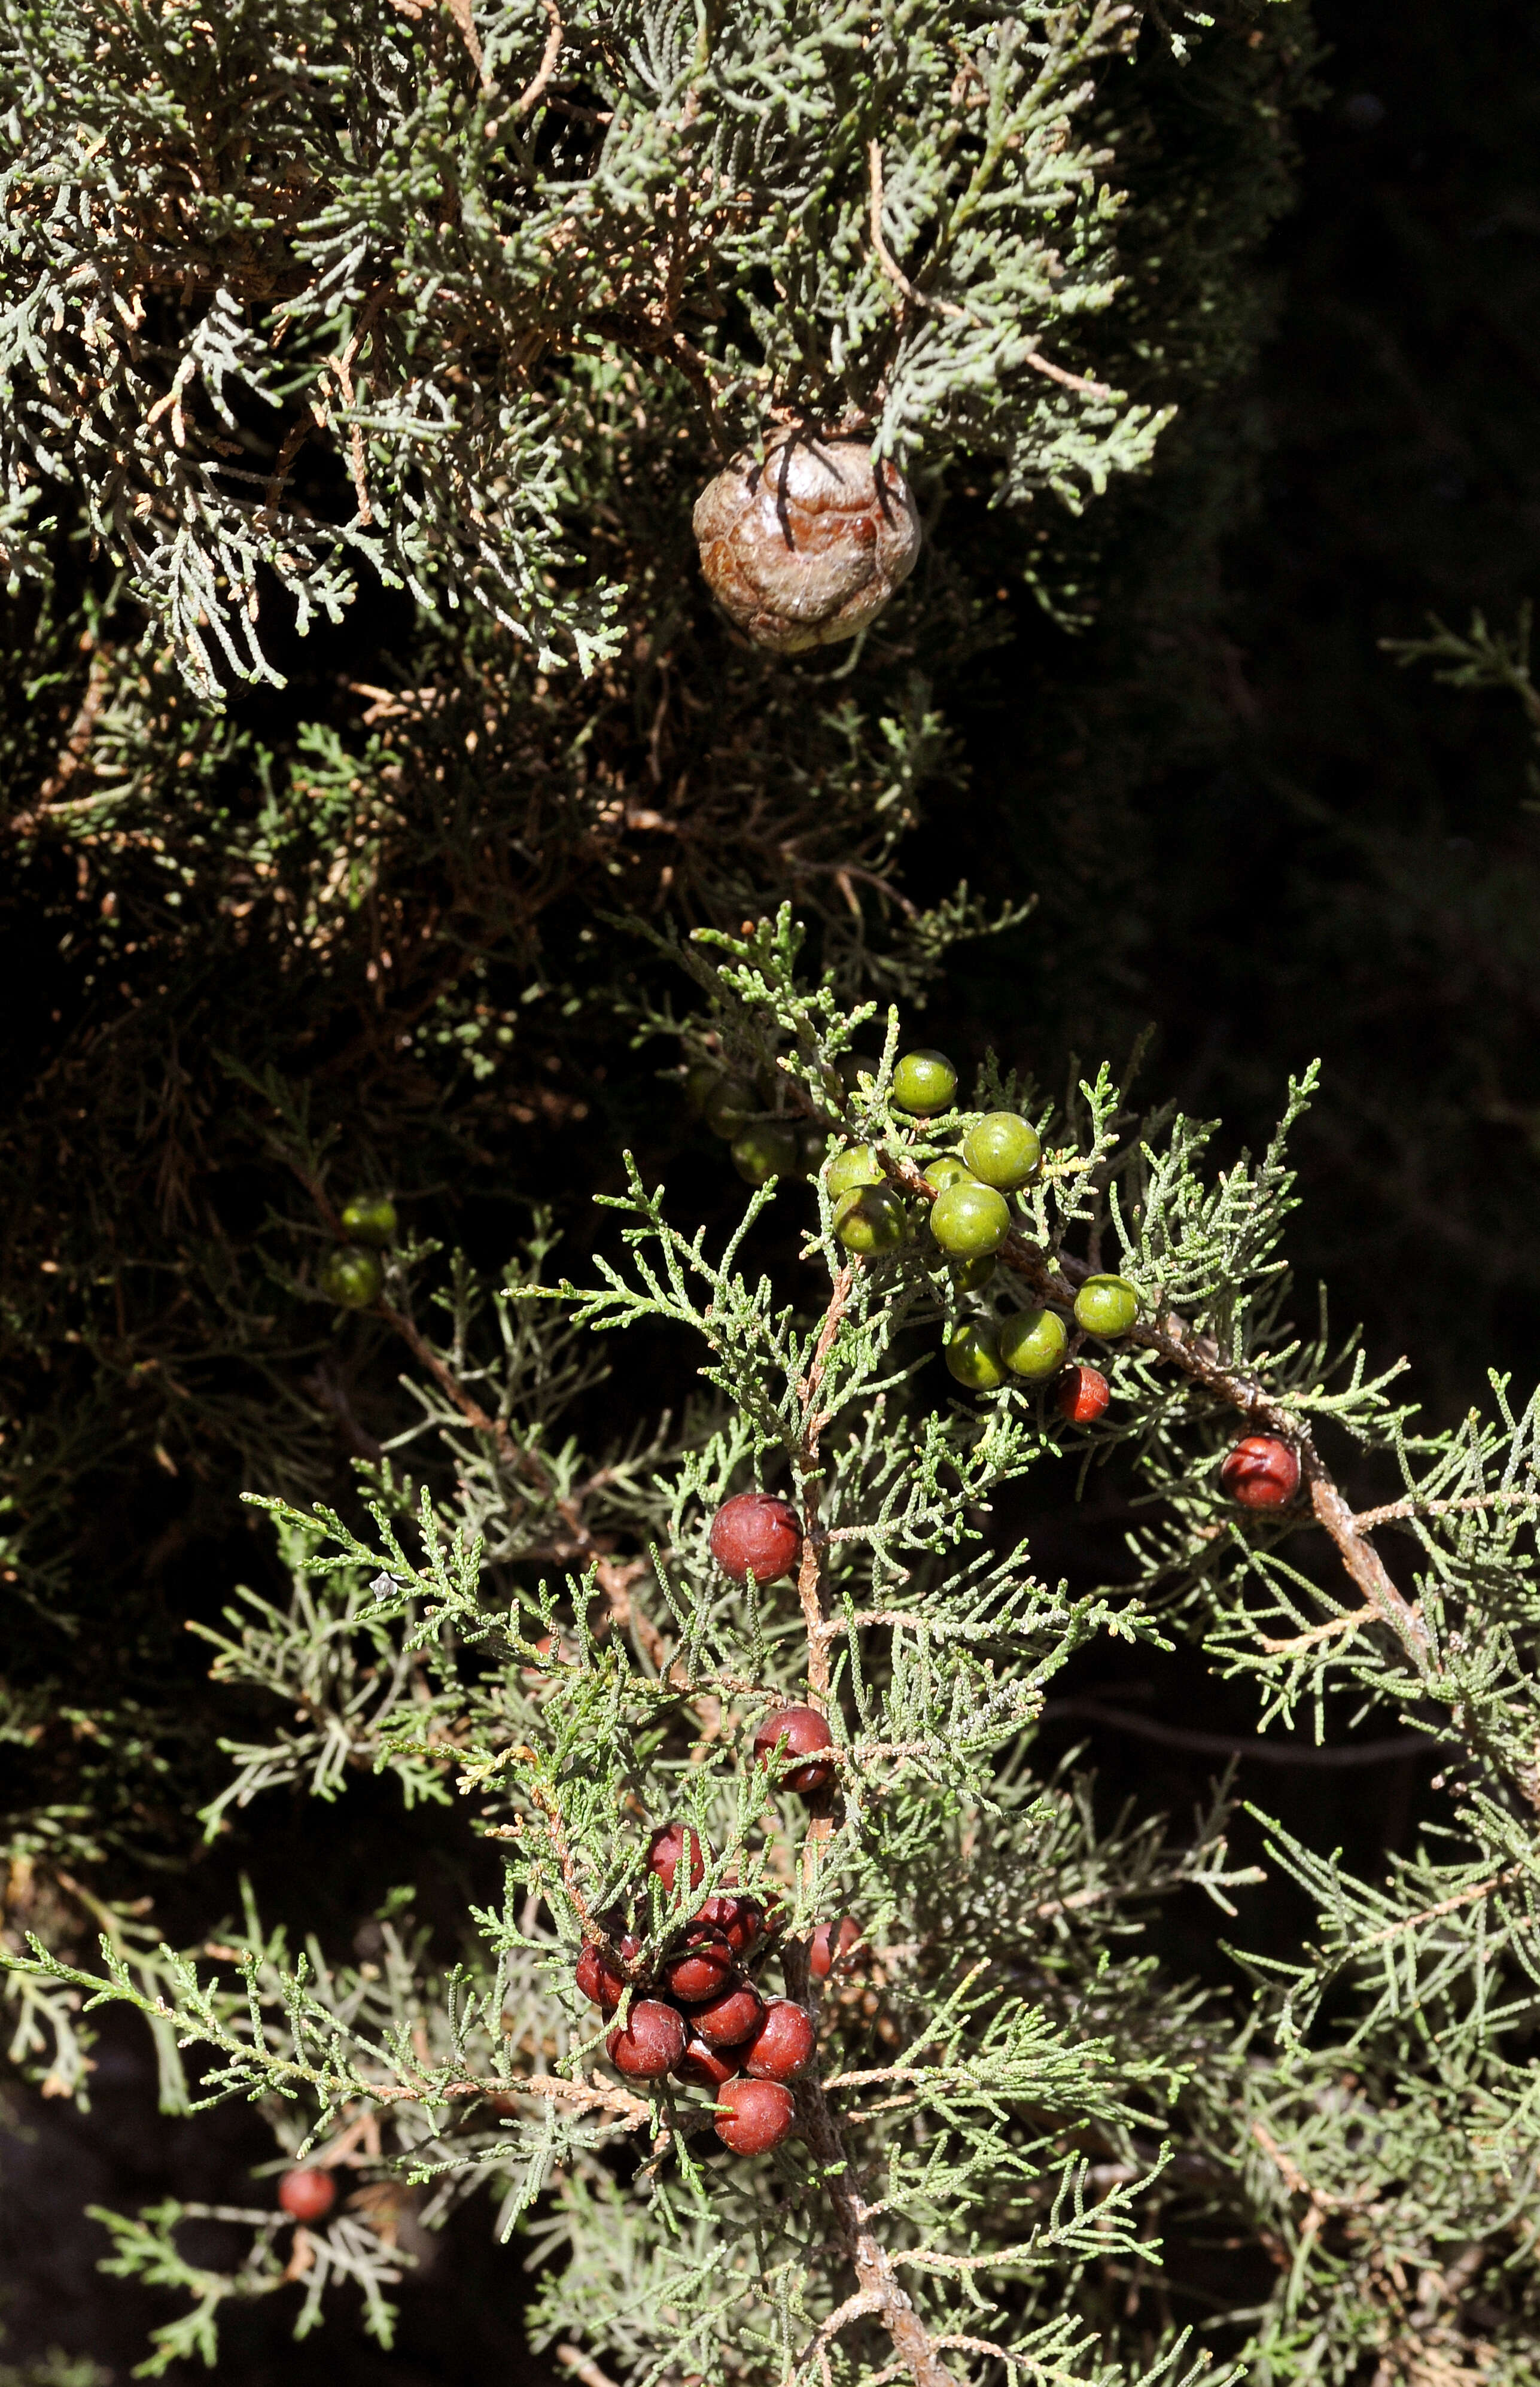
[[695, 434, 919, 654]]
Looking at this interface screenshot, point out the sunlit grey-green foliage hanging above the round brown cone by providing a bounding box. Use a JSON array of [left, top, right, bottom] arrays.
[[0, 0, 1208, 695]]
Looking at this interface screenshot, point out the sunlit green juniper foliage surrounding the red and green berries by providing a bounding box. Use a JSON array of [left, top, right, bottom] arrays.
[[7, 912, 1540, 2387]]
